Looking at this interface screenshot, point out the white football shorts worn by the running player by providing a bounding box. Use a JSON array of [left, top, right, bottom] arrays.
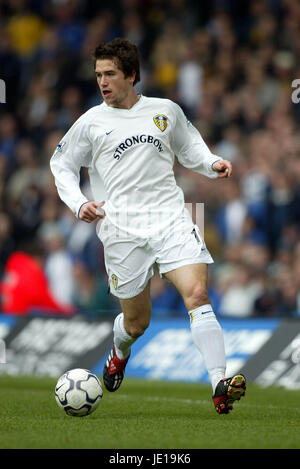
[[98, 209, 214, 299]]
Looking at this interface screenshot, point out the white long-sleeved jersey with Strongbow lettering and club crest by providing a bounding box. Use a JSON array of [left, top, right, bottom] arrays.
[[50, 96, 222, 235]]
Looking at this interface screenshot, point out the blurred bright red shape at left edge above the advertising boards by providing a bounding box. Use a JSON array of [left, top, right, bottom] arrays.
[[1, 251, 74, 315]]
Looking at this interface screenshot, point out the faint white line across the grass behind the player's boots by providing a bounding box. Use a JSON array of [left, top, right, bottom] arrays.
[[115, 394, 300, 411]]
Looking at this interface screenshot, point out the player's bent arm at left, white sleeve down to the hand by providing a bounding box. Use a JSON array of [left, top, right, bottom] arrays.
[[50, 115, 103, 222]]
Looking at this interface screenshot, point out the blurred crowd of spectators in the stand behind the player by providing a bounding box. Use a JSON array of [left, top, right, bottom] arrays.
[[0, 0, 300, 318]]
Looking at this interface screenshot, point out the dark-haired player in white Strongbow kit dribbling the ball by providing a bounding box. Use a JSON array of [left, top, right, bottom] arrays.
[[50, 38, 246, 414]]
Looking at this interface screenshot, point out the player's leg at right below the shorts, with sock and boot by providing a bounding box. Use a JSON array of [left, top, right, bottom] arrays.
[[164, 264, 246, 413]]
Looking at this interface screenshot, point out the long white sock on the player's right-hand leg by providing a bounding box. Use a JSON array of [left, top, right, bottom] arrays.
[[189, 304, 226, 393]]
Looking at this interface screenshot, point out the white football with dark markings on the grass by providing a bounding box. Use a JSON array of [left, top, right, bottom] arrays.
[[55, 368, 103, 417]]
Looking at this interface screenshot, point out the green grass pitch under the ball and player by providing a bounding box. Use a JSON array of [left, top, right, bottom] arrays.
[[0, 376, 300, 449]]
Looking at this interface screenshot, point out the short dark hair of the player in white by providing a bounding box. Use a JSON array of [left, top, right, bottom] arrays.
[[94, 37, 140, 85]]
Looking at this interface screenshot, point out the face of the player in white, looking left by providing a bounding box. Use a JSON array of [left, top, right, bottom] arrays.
[[95, 59, 134, 108]]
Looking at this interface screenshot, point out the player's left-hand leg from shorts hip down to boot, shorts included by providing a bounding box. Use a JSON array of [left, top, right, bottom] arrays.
[[100, 221, 155, 391]]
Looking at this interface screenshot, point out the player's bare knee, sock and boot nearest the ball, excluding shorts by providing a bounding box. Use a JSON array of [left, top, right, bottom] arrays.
[[103, 281, 151, 392]]
